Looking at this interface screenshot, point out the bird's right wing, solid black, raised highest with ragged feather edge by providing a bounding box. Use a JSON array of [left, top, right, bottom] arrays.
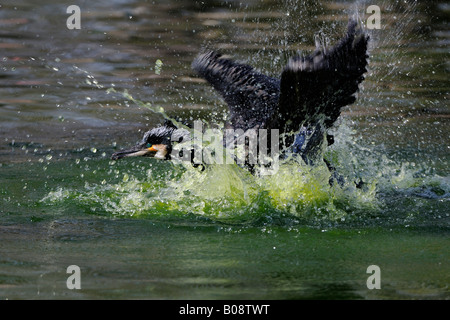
[[267, 20, 369, 132]]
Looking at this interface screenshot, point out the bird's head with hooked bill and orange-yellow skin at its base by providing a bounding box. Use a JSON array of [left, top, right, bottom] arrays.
[[111, 120, 190, 160]]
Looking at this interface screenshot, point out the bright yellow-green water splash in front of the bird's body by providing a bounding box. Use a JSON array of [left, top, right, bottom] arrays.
[[39, 117, 386, 222]]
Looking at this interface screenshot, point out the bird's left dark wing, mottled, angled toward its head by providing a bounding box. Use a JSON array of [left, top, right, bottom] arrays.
[[192, 51, 280, 131]]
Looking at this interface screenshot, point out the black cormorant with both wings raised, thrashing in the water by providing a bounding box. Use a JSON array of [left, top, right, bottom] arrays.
[[112, 19, 369, 171]]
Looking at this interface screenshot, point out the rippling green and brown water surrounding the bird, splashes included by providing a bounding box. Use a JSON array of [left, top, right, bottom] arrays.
[[0, 1, 450, 299]]
